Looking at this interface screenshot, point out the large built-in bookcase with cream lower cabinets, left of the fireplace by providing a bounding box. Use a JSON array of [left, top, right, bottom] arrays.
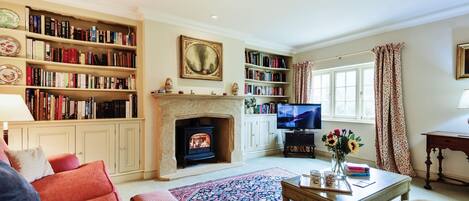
[[0, 0, 144, 181]]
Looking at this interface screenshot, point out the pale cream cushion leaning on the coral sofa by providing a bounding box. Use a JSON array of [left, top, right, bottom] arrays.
[[5, 147, 54, 182]]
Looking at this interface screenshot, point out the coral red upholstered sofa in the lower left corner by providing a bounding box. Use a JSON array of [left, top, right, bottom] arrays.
[[0, 137, 119, 201]]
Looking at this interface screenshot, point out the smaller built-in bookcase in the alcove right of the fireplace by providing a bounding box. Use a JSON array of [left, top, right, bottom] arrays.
[[244, 49, 291, 115]]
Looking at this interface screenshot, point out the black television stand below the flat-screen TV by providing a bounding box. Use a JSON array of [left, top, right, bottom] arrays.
[[283, 130, 316, 158]]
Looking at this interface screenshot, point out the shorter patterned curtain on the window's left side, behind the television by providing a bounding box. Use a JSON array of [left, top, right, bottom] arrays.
[[293, 61, 313, 103]]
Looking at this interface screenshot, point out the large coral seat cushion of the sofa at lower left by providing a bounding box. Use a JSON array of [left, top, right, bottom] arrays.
[[32, 161, 115, 201]]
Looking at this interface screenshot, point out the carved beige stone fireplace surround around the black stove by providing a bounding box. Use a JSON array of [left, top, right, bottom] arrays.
[[153, 94, 244, 180]]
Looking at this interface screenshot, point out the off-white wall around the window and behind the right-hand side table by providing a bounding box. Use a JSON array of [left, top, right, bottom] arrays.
[[294, 15, 469, 178]]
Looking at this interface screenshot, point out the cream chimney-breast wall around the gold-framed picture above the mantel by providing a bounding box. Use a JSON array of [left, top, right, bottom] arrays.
[[143, 20, 245, 171]]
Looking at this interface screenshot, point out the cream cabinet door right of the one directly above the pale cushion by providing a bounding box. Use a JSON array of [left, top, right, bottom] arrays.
[[76, 124, 116, 174]]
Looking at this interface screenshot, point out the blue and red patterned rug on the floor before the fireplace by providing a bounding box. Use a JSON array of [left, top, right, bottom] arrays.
[[169, 168, 296, 201]]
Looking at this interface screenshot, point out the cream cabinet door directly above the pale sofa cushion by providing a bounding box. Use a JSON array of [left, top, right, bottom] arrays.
[[28, 126, 75, 156]]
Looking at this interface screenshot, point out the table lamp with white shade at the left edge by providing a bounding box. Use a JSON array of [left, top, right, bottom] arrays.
[[0, 94, 34, 144]]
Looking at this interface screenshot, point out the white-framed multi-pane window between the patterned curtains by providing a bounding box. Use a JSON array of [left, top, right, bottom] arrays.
[[311, 63, 375, 120]]
